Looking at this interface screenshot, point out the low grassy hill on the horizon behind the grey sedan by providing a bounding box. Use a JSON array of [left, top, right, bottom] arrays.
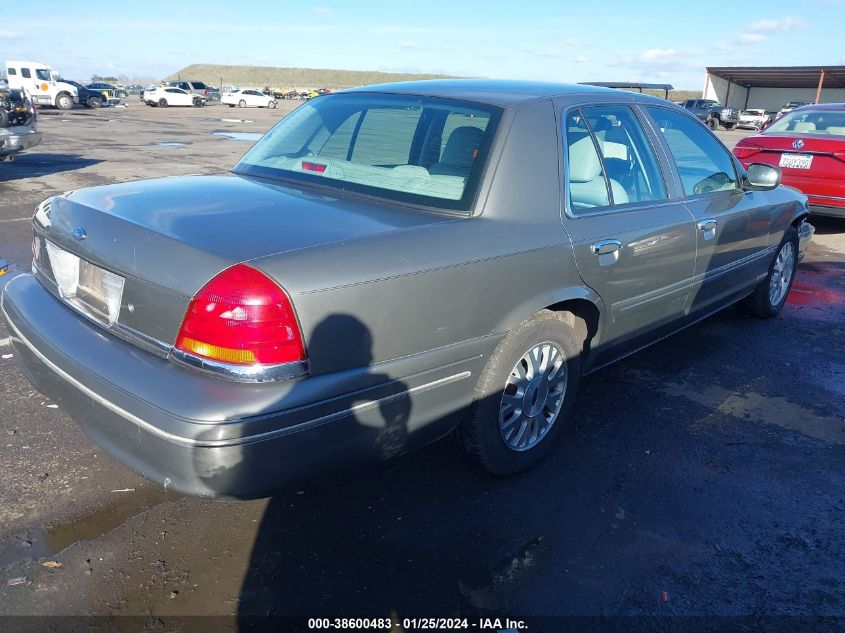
[[165, 64, 458, 90]]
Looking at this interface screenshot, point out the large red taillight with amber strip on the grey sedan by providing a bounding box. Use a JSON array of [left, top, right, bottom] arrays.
[[176, 264, 305, 365]]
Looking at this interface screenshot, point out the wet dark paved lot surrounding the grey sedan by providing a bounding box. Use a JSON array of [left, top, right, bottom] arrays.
[[0, 102, 845, 631]]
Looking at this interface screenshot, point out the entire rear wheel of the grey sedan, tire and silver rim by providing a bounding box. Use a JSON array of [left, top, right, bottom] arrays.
[[456, 310, 581, 475]]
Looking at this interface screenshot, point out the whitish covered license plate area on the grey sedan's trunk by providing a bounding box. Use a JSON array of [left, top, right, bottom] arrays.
[[46, 242, 125, 325]]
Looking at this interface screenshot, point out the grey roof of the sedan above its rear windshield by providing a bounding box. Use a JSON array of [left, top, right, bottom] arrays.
[[342, 79, 667, 107]]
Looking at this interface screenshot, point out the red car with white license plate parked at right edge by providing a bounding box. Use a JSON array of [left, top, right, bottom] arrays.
[[733, 103, 845, 218]]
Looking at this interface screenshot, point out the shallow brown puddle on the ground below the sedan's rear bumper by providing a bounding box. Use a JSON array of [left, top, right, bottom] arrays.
[[0, 486, 179, 568]]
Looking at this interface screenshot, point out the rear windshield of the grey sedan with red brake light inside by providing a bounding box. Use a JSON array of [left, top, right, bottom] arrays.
[[234, 93, 501, 211]]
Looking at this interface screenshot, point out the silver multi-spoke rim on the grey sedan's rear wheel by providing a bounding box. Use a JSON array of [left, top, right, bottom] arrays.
[[499, 343, 566, 451]]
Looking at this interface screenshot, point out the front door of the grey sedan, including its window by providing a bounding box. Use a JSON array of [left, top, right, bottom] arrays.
[[644, 106, 776, 312]]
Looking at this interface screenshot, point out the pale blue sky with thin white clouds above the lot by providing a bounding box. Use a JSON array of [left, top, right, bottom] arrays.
[[0, 0, 845, 90]]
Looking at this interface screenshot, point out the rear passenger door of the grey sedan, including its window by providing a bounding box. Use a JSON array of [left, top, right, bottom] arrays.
[[562, 104, 696, 358]]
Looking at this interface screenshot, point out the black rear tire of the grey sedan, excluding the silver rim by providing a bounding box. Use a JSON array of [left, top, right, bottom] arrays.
[[456, 310, 582, 475]]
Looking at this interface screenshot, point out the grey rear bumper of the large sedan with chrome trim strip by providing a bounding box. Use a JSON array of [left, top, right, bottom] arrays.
[[0, 275, 484, 499]]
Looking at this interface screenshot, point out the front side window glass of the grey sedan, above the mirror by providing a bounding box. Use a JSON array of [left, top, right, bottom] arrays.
[[646, 106, 739, 196]]
